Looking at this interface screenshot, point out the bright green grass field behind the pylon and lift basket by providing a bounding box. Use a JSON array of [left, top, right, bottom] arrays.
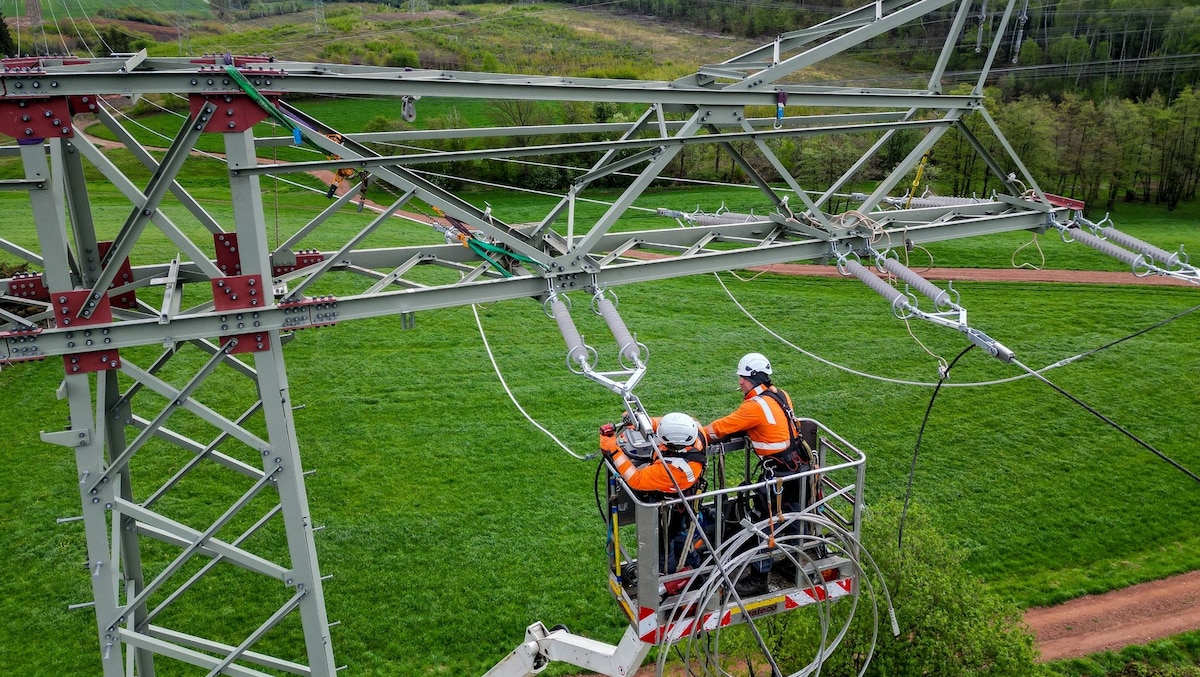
[[0, 151, 1200, 675]]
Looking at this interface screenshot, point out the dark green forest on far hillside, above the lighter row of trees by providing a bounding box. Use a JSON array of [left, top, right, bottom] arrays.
[[609, 0, 1200, 101]]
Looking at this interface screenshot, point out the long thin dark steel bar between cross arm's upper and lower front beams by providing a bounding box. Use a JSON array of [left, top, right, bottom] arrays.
[[236, 117, 964, 176]]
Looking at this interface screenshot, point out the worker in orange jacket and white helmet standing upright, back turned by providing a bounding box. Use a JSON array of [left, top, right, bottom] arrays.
[[704, 353, 811, 595]]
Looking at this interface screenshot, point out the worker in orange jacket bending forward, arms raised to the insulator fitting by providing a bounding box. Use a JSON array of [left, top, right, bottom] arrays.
[[600, 412, 707, 573]]
